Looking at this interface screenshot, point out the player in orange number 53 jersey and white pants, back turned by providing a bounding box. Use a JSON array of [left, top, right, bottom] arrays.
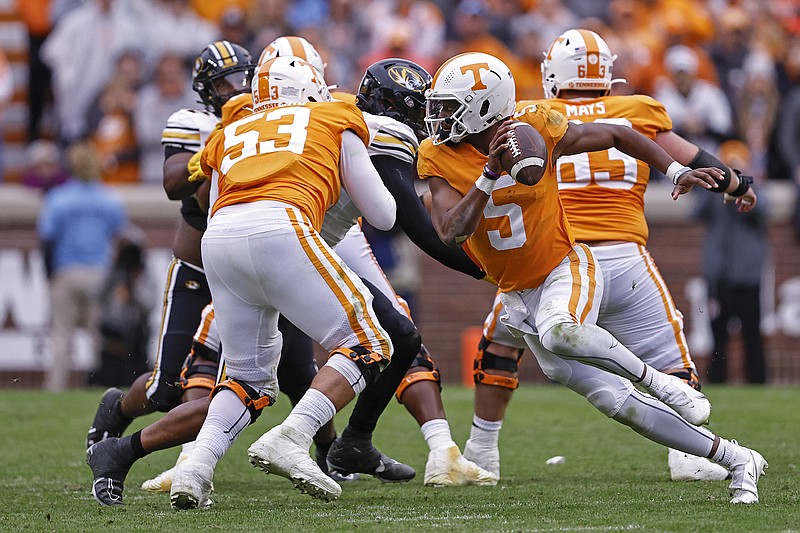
[[170, 57, 396, 509]]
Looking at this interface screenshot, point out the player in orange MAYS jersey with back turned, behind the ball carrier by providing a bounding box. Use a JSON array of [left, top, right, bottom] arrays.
[[464, 30, 756, 486]]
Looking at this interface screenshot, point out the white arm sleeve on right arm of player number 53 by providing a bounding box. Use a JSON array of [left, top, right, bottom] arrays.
[[339, 130, 397, 231]]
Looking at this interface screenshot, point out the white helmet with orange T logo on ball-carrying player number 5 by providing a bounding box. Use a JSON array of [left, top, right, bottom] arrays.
[[425, 52, 516, 144]]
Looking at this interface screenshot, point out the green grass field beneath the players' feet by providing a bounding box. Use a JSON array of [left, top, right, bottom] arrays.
[[0, 385, 800, 532]]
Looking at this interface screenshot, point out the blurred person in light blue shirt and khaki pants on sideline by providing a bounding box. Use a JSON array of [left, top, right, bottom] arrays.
[[37, 143, 127, 391]]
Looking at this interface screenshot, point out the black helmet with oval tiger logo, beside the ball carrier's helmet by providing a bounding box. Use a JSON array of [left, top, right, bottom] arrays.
[[356, 58, 431, 140]]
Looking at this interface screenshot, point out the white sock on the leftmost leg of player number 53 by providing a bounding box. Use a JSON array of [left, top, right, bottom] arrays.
[[192, 389, 250, 463]]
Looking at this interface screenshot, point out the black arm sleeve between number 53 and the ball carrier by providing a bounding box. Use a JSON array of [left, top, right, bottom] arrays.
[[372, 155, 486, 279]]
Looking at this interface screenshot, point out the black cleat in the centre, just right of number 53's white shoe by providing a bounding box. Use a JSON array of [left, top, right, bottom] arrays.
[[327, 437, 417, 483]]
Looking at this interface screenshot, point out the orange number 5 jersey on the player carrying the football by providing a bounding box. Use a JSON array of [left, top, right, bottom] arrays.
[[417, 104, 574, 292]]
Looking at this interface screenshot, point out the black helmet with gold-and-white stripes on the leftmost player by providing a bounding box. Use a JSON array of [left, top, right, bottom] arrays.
[[192, 41, 256, 117]]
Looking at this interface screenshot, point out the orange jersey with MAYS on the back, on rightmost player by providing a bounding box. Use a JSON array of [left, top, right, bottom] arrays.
[[521, 95, 672, 245]]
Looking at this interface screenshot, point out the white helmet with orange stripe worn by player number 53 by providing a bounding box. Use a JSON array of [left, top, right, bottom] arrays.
[[252, 56, 331, 111]]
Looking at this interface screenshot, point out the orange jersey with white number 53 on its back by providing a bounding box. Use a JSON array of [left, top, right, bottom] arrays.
[[201, 102, 369, 230]]
